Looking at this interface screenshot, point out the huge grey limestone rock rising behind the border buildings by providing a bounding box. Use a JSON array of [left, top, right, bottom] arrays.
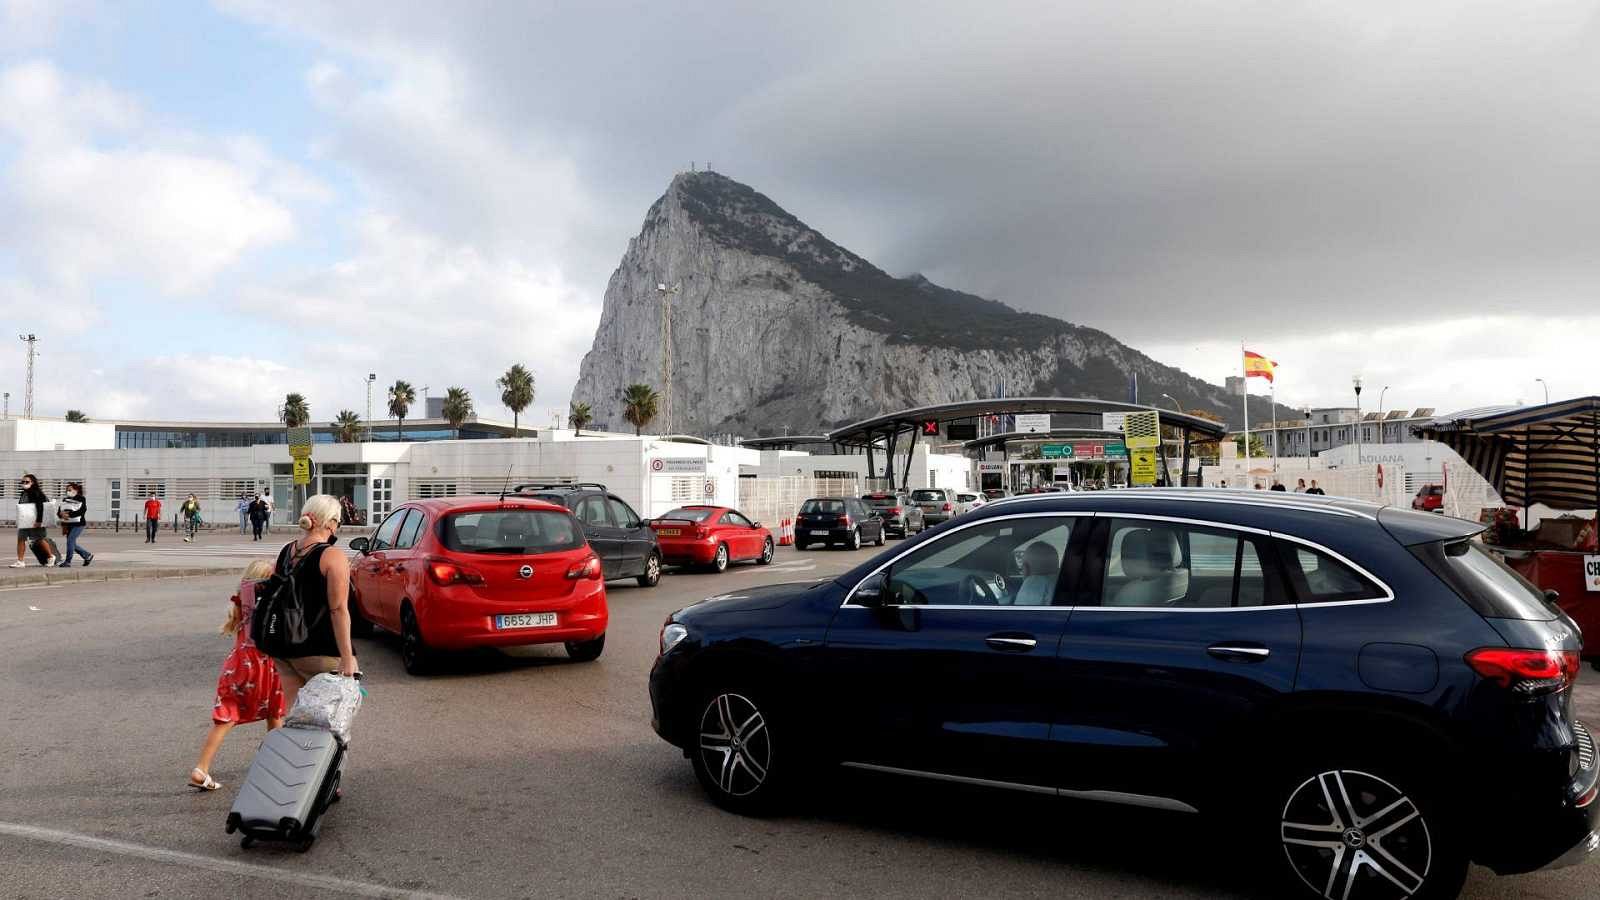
[[573, 173, 1286, 437]]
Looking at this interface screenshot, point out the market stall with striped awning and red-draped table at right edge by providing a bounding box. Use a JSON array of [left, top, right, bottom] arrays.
[[1416, 397, 1600, 657]]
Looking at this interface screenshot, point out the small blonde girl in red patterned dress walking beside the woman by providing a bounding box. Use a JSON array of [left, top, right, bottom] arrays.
[[189, 559, 288, 791]]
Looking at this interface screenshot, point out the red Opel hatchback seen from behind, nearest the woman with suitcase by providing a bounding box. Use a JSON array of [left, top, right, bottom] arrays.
[[350, 496, 608, 674]]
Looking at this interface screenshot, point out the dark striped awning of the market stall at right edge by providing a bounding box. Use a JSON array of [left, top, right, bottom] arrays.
[[1413, 396, 1600, 509]]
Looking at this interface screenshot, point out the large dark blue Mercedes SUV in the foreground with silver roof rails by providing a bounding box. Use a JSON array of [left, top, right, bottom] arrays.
[[650, 488, 1600, 900]]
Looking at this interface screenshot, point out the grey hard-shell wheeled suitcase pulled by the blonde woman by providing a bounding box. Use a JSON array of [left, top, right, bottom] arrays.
[[227, 727, 344, 852]]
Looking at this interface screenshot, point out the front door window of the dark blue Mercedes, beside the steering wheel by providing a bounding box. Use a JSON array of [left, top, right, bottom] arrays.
[[885, 516, 1077, 607]]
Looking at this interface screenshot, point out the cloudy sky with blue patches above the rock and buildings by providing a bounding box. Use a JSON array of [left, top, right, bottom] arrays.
[[0, 0, 1600, 423]]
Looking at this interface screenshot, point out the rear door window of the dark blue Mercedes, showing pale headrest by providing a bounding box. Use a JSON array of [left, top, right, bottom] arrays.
[[1101, 519, 1285, 609]]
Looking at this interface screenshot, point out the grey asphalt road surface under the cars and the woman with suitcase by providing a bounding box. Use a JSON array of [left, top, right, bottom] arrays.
[[0, 538, 1600, 898]]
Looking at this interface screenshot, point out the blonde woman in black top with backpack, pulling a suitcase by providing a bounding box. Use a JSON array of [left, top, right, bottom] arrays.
[[272, 493, 360, 709]]
